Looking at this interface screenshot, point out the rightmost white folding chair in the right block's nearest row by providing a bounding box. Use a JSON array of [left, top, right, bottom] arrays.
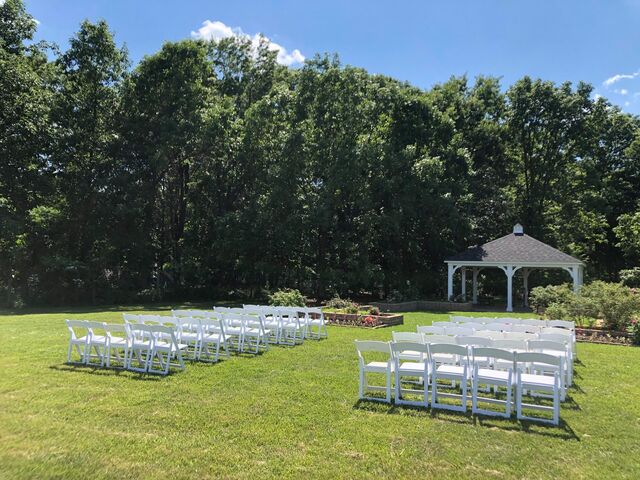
[[515, 352, 562, 425]]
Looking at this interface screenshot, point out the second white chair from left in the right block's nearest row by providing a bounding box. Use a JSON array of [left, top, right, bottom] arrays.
[[391, 341, 431, 407]]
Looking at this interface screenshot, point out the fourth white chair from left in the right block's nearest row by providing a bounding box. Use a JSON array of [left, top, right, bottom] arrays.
[[471, 347, 515, 418]]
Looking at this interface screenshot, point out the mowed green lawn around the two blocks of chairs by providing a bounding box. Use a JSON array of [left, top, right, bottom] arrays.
[[0, 309, 640, 479]]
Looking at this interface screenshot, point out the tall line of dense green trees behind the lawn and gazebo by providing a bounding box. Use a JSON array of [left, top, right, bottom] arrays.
[[0, 0, 640, 305]]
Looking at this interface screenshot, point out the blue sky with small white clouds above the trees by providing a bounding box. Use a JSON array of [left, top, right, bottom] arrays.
[[26, 0, 640, 114]]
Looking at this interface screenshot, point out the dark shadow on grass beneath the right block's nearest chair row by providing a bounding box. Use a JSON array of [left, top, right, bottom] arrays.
[[352, 397, 580, 442]]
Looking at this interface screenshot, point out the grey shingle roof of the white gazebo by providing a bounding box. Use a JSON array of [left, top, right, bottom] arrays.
[[446, 233, 582, 265]]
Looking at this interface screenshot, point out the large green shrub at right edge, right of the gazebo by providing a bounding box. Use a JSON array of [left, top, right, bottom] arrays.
[[580, 280, 640, 330]]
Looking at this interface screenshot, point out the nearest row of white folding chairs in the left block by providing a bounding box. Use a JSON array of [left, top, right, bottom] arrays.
[[66, 320, 188, 375]]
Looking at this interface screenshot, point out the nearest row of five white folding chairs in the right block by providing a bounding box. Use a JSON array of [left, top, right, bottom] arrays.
[[355, 340, 564, 425]]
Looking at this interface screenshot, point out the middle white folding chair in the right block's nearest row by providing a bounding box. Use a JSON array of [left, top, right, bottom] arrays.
[[429, 343, 471, 412]]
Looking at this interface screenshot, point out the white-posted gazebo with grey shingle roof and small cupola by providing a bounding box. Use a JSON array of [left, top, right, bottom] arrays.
[[445, 223, 584, 312]]
